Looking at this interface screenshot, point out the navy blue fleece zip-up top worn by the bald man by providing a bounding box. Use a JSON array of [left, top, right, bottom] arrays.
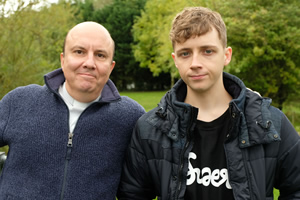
[[0, 69, 145, 200]]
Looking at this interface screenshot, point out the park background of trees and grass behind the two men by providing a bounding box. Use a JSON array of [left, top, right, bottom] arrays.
[[0, 0, 300, 197]]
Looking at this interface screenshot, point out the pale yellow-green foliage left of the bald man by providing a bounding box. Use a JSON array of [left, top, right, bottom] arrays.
[[0, 1, 76, 98]]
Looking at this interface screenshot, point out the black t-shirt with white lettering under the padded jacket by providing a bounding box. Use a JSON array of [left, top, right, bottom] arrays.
[[185, 109, 234, 200]]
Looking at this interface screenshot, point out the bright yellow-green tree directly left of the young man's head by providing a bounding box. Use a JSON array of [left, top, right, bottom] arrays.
[[133, 0, 211, 85]]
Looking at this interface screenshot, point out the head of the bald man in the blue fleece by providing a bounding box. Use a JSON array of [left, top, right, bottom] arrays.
[[60, 22, 115, 102]]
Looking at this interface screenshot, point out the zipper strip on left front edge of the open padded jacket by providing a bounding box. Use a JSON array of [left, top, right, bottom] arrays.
[[175, 109, 195, 199]]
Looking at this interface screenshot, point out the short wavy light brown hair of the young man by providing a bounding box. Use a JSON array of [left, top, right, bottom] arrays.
[[170, 7, 227, 48]]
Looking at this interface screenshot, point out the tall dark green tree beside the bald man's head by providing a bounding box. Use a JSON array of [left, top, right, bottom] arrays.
[[93, 0, 145, 90]]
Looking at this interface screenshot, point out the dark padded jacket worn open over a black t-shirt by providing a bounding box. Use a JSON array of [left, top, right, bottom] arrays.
[[118, 73, 300, 200]]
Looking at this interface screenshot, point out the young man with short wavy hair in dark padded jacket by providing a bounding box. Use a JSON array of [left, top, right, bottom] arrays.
[[118, 7, 300, 200]]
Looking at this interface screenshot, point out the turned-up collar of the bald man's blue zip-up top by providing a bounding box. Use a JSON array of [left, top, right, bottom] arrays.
[[44, 68, 121, 102]]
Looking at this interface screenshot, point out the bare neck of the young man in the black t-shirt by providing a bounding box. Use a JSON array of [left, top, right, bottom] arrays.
[[185, 84, 232, 122]]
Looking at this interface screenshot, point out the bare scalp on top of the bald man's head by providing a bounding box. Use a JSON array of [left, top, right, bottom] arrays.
[[63, 21, 115, 58]]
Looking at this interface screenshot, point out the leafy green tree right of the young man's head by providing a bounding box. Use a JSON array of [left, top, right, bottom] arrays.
[[218, 0, 300, 109]]
